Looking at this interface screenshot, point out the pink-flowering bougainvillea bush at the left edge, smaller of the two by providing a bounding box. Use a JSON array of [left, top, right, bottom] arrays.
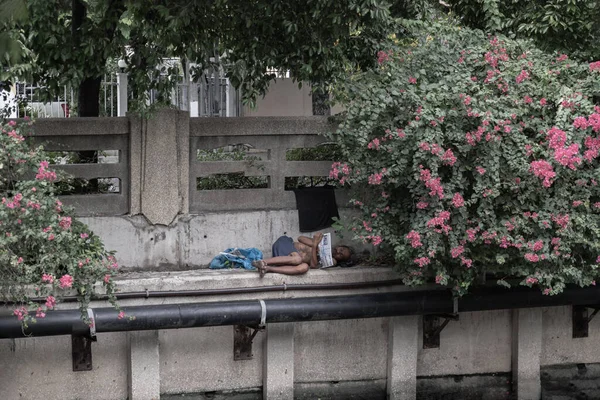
[[0, 121, 123, 325]]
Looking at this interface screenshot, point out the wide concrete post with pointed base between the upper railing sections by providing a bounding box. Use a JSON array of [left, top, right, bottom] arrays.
[[130, 109, 190, 225]]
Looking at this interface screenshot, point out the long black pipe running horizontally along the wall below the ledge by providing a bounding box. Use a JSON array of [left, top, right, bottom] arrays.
[[0, 287, 600, 338]]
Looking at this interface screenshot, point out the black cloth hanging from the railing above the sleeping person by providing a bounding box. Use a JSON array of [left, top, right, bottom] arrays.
[[294, 186, 339, 232]]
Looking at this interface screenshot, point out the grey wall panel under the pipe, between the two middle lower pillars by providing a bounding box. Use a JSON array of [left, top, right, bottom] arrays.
[[294, 318, 388, 383]]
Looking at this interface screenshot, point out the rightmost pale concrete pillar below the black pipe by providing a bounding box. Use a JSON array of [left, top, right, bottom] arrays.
[[512, 308, 542, 400]]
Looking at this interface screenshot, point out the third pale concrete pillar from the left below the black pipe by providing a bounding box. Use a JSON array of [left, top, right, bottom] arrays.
[[387, 315, 419, 400]]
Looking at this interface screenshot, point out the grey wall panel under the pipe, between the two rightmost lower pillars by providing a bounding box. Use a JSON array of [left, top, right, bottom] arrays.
[[417, 310, 511, 376]]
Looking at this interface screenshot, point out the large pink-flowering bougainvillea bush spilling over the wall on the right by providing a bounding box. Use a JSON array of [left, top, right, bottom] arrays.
[[331, 21, 600, 295]]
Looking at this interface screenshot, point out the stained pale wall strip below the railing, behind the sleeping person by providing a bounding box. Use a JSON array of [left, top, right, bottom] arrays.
[[80, 208, 368, 269]]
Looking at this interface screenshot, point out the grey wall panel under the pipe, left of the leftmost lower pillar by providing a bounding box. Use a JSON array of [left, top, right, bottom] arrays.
[[0, 333, 127, 400]]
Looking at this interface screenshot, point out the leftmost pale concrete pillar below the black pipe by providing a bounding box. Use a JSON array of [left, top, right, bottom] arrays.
[[127, 331, 160, 400]]
